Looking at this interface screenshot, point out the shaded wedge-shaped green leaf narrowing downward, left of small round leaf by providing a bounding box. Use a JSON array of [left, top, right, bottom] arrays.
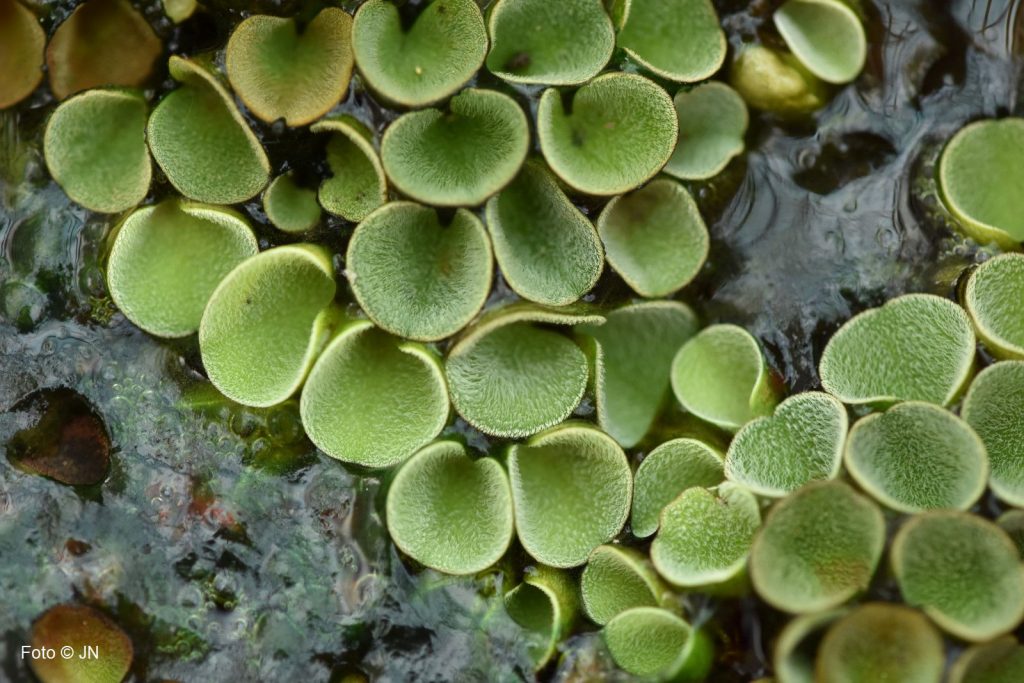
[[577, 301, 697, 448]]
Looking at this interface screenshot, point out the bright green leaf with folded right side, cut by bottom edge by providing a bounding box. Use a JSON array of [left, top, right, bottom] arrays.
[[602, 607, 714, 681]]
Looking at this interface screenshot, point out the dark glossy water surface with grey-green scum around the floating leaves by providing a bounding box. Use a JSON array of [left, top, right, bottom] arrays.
[[0, 0, 1024, 682]]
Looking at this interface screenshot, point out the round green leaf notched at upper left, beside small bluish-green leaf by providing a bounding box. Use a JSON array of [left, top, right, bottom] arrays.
[[537, 73, 679, 196]]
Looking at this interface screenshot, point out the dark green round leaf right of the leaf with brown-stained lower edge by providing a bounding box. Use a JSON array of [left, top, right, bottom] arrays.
[[892, 511, 1024, 641]]
